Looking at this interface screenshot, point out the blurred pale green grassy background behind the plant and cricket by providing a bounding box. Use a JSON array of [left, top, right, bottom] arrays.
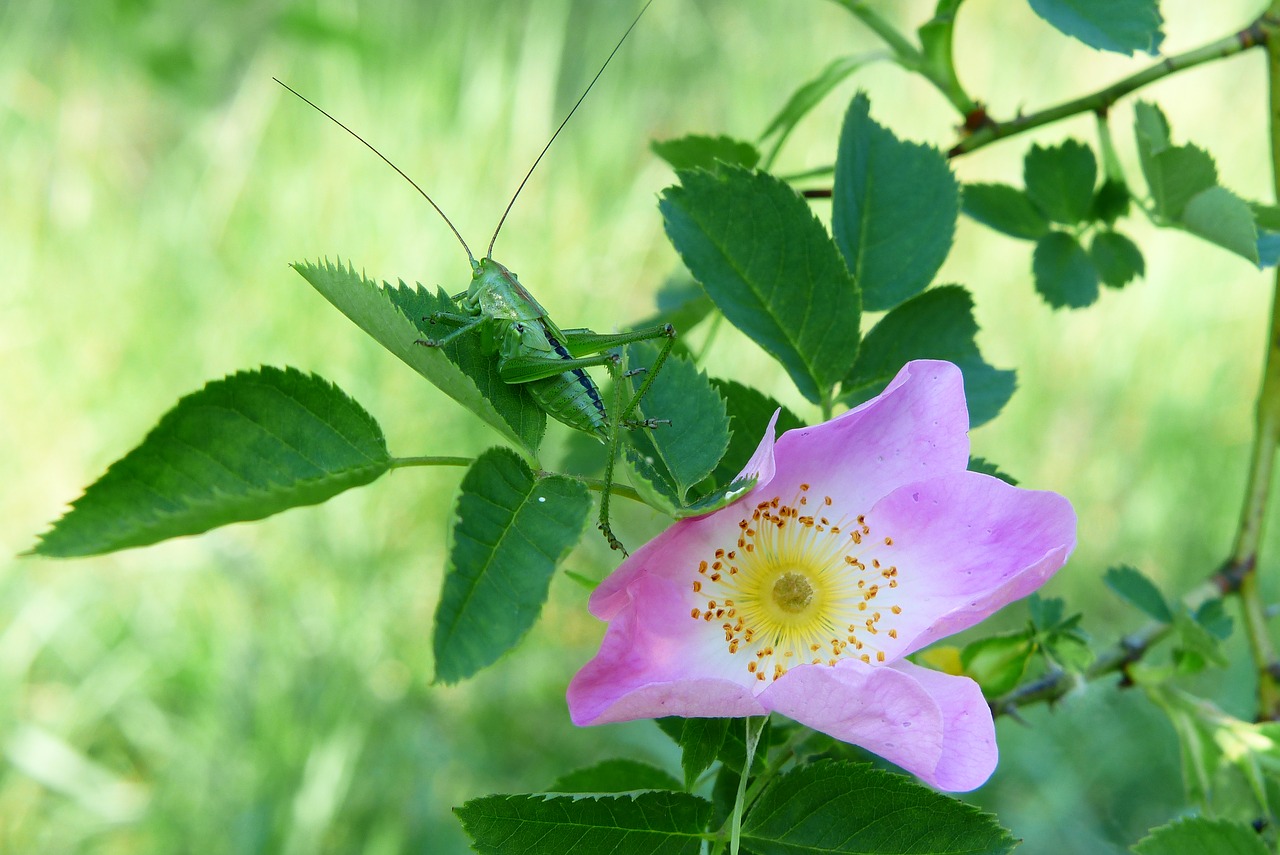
[[0, 0, 1280, 855]]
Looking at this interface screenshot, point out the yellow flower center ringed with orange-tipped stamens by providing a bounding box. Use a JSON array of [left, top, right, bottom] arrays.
[[690, 484, 902, 682]]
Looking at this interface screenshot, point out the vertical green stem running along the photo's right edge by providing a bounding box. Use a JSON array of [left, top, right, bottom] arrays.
[[1226, 6, 1280, 721]]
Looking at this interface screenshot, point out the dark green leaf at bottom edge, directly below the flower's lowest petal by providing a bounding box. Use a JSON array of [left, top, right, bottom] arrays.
[[742, 760, 1016, 855]]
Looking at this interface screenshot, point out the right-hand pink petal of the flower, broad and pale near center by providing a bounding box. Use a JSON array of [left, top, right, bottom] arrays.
[[861, 472, 1075, 658]]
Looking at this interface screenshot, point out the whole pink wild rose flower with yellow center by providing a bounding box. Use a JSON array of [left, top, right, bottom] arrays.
[[568, 360, 1075, 792]]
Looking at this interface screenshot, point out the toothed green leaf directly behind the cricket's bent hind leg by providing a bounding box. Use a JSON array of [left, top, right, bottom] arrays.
[[627, 342, 728, 506]]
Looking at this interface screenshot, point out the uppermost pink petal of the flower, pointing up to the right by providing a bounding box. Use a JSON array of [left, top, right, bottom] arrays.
[[769, 360, 969, 513]]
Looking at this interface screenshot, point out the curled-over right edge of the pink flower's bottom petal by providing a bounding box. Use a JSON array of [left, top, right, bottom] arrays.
[[893, 660, 1000, 792]]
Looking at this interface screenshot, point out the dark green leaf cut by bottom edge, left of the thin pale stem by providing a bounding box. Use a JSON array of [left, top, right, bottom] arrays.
[[454, 792, 712, 855]]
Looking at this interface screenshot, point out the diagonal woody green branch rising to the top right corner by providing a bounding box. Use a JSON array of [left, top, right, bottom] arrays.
[[947, 13, 1277, 157]]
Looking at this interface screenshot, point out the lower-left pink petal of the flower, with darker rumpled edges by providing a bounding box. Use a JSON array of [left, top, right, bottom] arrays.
[[568, 570, 765, 724]]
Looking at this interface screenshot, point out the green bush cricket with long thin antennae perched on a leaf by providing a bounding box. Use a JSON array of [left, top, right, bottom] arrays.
[[276, 0, 676, 554]]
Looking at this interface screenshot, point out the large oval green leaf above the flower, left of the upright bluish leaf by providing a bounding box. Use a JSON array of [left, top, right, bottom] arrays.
[[659, 168, 861, 402]]
